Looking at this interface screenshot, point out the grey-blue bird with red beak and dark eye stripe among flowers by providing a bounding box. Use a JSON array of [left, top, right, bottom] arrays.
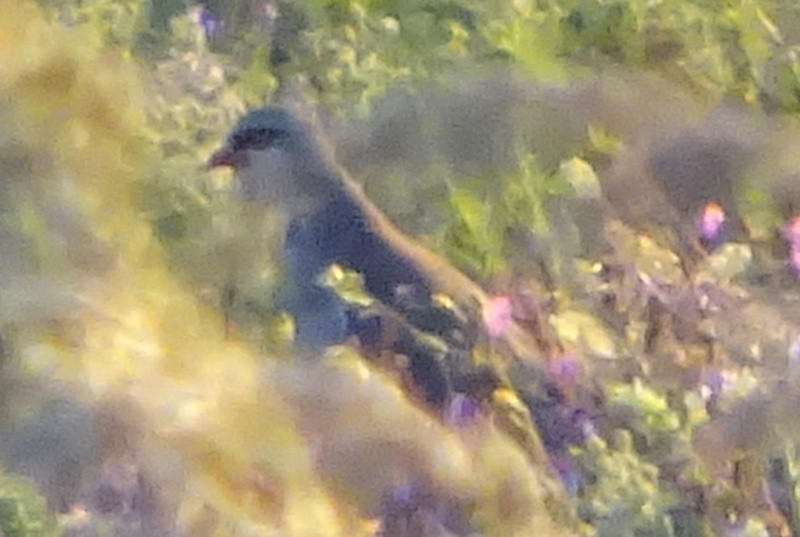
[[206, 106, 592, 522]]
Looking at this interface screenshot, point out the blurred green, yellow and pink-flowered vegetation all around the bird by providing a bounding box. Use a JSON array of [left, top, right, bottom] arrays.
[[0, 0, 800, 537]]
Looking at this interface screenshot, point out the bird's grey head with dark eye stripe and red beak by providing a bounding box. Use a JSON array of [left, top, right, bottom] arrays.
[[207, 107, 330, 208]]
